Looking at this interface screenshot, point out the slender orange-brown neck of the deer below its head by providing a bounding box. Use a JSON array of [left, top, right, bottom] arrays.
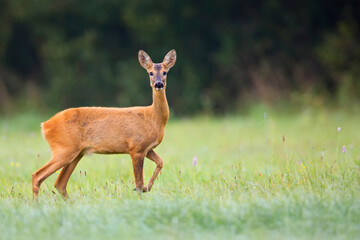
[[151, 89, 169, 125]]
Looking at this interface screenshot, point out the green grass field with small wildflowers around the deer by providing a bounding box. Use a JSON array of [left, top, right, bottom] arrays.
[[0, 107, 360, 239]]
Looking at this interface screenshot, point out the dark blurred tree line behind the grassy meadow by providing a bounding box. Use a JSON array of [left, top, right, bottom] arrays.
[[0, 0, 360, 114]]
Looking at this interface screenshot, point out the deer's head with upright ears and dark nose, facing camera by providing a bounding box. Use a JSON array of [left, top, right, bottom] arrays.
[[139, 49, 176, 91]]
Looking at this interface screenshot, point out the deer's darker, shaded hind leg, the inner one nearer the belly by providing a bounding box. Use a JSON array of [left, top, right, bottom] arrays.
[[54, 153, 84, 198]]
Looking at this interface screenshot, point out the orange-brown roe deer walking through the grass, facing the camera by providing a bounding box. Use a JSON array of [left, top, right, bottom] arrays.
[[32, 50, 176, 199]]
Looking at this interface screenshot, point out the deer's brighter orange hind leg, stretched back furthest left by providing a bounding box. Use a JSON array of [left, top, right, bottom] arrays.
[[32, 152, 79, 200]]
